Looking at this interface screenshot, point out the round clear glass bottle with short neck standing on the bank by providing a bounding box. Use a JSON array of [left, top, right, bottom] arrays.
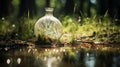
[[34, 8, 62, 39]]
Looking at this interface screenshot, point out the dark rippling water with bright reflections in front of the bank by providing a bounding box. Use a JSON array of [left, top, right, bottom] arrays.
[[0, 48, 120, 67]]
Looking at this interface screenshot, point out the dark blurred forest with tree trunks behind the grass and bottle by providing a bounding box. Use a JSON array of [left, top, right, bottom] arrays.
[[0, 0, 120, 19]]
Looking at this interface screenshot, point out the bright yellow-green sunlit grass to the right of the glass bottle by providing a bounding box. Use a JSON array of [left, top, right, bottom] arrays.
[[62, 14, 119, 42]]
